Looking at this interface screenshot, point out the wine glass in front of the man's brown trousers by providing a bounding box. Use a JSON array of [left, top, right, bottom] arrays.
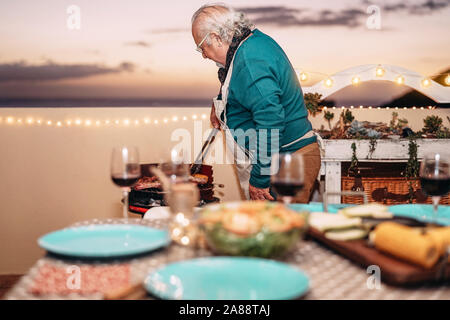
[[271, 153, 305, 204]]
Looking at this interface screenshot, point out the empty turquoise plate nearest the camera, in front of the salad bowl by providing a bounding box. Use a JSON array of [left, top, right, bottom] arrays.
[[145, 257, 309, 300]]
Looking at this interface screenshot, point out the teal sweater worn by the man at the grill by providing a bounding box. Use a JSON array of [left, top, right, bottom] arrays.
[[219, 29, 316, 188]]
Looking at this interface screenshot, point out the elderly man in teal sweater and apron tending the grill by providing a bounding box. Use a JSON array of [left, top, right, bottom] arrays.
[[192, 5, 320, 203]]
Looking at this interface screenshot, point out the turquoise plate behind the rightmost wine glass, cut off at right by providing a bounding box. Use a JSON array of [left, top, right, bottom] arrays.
[[389, 204, 450, 226]]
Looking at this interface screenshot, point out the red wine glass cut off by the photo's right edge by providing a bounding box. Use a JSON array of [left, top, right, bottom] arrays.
[[419, 153, 450, 223]]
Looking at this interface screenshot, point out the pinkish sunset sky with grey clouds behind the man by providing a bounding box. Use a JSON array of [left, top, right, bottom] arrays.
[[0, 0, 450, 102]]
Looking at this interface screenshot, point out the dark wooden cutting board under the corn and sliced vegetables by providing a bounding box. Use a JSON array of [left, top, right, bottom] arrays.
[[308, 228, 450, 286]]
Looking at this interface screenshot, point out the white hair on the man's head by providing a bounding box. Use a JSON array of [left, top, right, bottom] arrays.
[[191, 3, 254, 45]]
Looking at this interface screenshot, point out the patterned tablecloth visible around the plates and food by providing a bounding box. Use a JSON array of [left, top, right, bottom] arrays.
[[5, 219, 450, 300]]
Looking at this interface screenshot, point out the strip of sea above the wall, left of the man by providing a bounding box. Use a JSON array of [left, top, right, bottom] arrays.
[[0, 98, 211, 108]]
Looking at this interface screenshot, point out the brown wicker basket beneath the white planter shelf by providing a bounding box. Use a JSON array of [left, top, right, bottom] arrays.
[[341, 176, 450, 205]]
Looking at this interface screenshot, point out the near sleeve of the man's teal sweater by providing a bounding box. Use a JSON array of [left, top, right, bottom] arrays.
[[233, 59, 285, 188]]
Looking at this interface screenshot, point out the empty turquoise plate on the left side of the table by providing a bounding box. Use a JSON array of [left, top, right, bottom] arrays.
[[38, 224, 170, 258]]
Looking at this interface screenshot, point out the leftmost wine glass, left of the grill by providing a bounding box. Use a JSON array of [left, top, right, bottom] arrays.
[[111, 147, 141, 219]]
